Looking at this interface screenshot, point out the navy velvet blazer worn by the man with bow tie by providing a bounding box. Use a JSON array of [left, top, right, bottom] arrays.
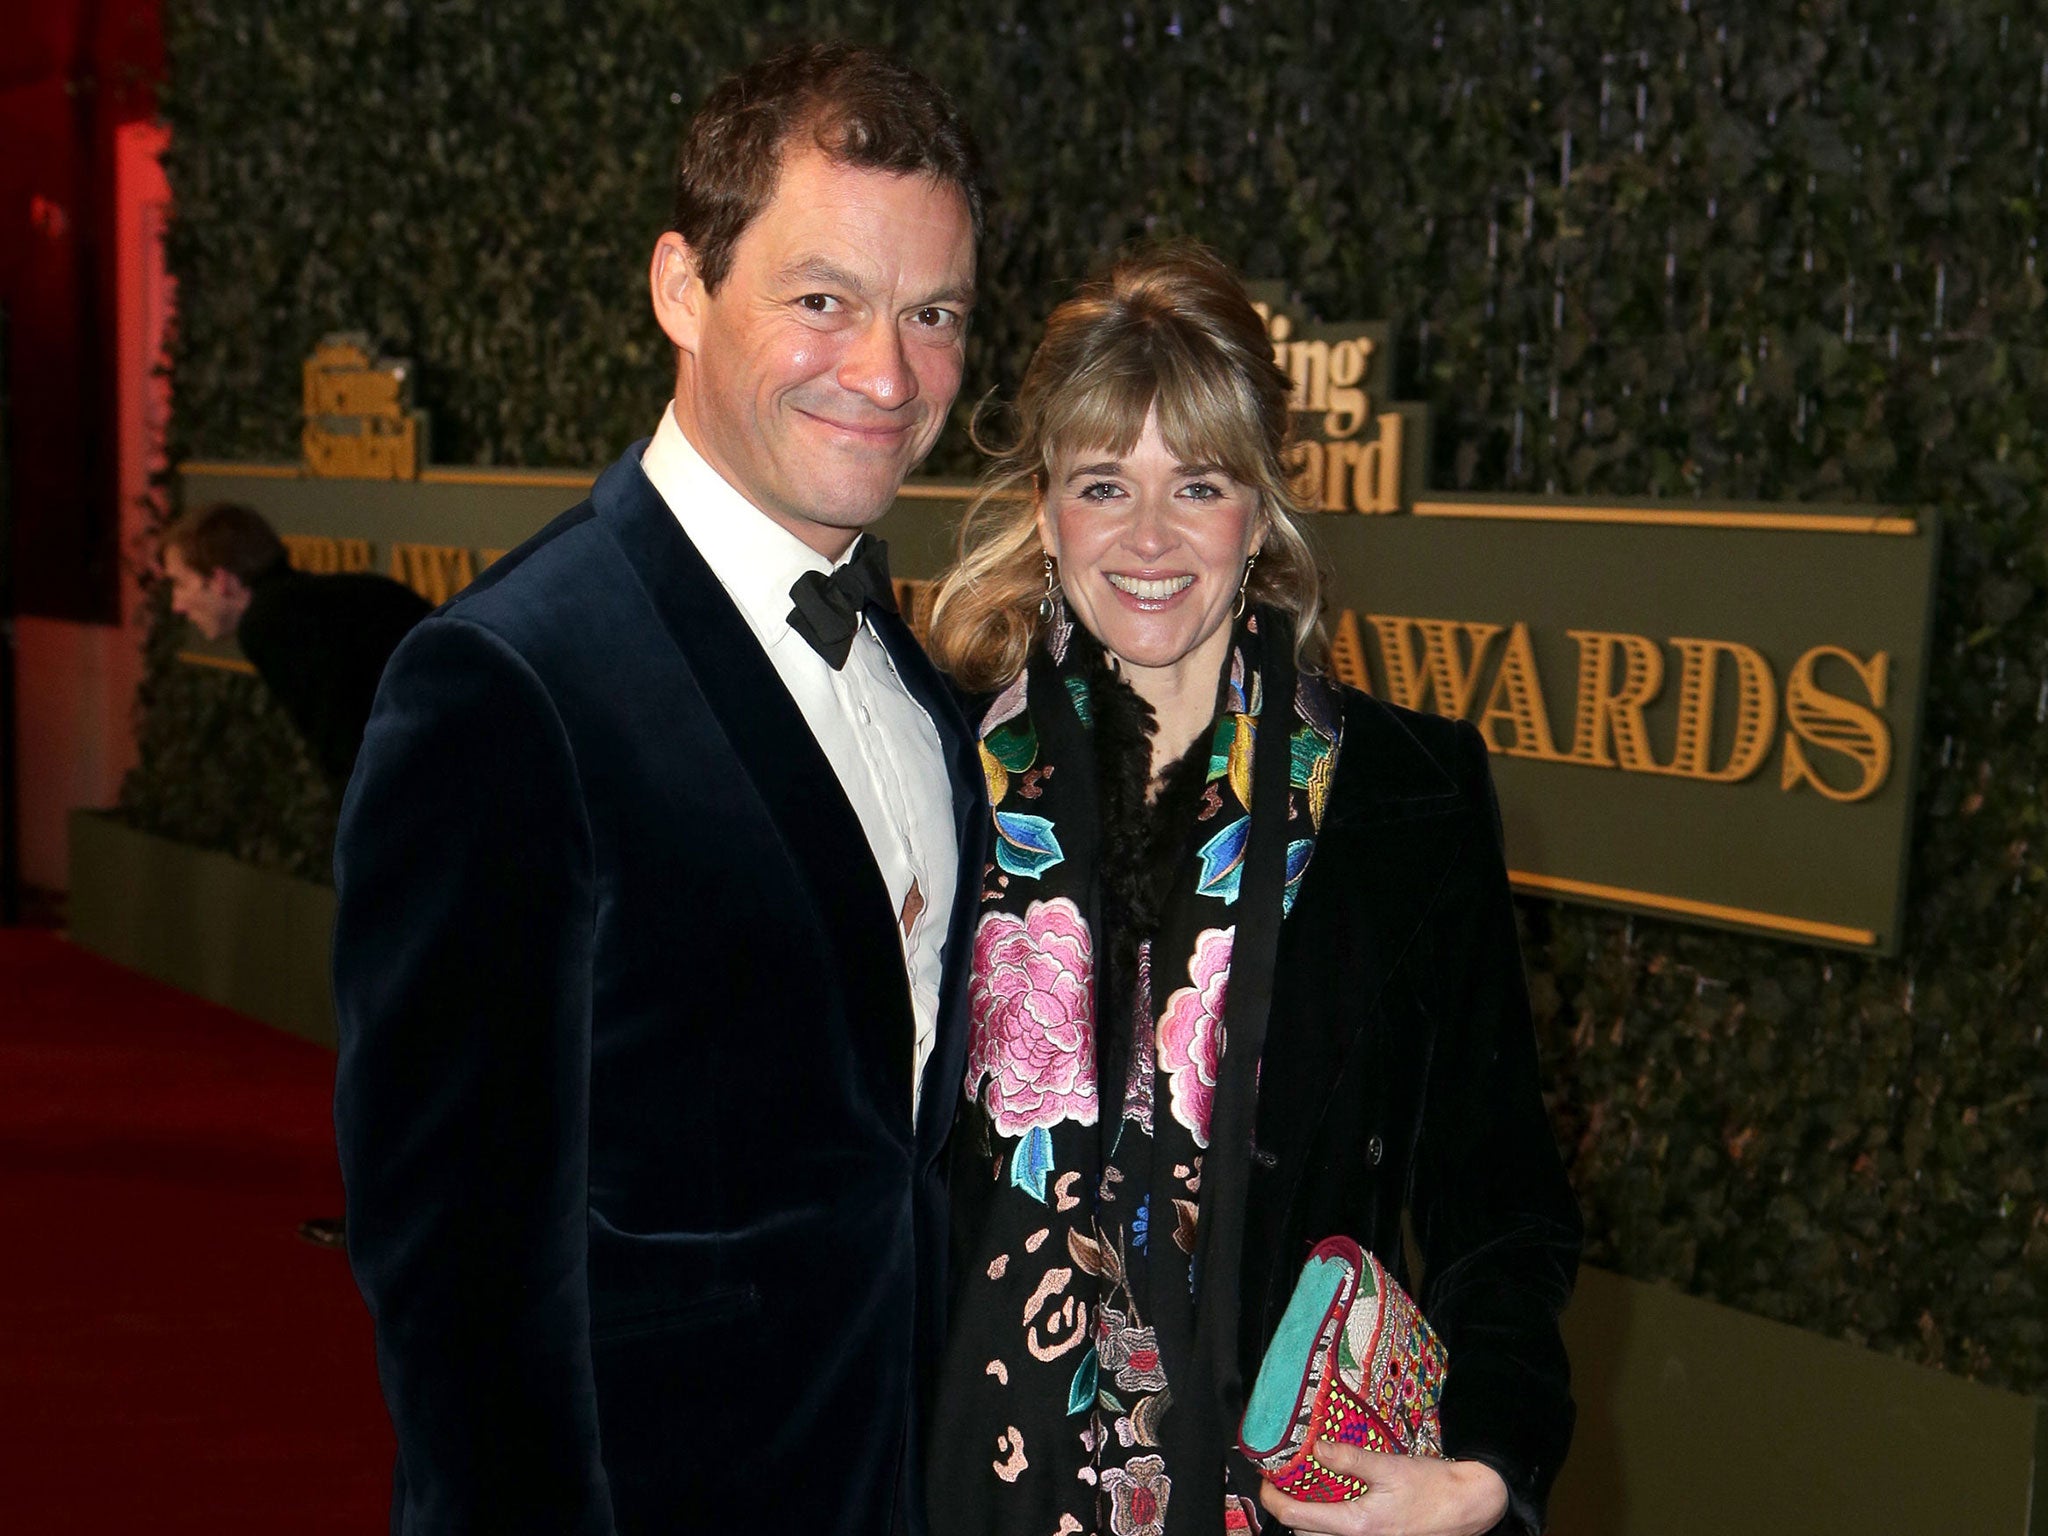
[[334, 444, 987, 1536]]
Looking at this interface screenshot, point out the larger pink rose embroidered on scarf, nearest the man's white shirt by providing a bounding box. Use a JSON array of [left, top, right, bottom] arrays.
[[967, 897, 1096, 1137]]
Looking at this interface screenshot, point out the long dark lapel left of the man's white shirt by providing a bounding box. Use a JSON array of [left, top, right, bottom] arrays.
[[592, 442, 913, 1104]]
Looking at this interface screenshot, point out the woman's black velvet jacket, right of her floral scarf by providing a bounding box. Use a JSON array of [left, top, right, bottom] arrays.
[[1237, 690, 1581, 1530]]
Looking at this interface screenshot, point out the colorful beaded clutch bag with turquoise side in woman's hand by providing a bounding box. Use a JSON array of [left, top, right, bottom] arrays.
[[1237, 1237, 1446, 1503]]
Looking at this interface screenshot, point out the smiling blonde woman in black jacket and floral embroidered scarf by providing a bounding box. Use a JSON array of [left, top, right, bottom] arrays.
[[928, 248, 1579, 1536]]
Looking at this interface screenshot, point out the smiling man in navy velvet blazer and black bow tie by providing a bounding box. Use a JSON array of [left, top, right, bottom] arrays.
[[334, 45, 985, 1536]]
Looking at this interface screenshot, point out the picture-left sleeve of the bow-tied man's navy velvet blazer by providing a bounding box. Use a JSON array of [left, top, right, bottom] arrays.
[[334, 616, 612, 1536]]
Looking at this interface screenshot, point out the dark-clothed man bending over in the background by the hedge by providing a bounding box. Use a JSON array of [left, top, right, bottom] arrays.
[[162, 502, 428, 795]]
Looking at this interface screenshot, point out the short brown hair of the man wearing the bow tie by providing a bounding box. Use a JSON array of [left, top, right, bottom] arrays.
[[670, 43, 983, 293]]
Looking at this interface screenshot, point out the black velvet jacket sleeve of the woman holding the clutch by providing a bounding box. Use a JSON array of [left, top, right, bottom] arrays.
[[1413, 723, 1583, 1532]]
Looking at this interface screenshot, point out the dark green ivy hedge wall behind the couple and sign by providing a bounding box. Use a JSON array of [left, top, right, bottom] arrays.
[[144, 0, 2048, 1391]]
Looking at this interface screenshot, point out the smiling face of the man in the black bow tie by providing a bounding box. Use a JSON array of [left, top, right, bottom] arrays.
[[651, 150, 975, 557]]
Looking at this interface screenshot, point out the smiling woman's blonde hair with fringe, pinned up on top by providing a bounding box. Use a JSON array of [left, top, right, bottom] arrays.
[[928, 244, 1323, 692]]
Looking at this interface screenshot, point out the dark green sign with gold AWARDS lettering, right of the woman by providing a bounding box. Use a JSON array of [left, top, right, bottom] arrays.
[[1268, 301, 1937, 952]]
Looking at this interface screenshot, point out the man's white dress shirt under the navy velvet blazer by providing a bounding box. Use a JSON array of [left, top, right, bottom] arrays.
[[641, 408, 961, 1118]]
